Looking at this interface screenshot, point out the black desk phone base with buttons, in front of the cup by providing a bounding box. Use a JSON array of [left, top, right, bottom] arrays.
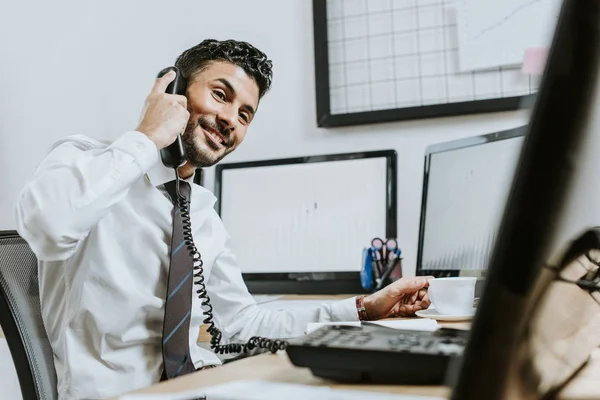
[[286, 322, 468, 385]]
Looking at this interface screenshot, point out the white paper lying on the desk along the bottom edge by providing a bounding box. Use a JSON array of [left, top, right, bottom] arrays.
[[120, 380, 442, 400]]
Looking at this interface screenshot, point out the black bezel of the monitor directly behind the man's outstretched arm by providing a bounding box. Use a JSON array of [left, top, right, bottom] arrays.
[[215, 149, 398, 294]]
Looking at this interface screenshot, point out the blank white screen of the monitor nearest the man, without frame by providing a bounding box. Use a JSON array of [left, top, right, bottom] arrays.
[[219, 157, 395, 273]]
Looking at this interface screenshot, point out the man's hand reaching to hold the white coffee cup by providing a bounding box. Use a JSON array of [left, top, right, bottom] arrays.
[[364, 276, 433, 320]]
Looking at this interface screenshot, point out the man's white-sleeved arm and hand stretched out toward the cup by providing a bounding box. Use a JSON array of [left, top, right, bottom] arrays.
[[207, 230, 433, 343]]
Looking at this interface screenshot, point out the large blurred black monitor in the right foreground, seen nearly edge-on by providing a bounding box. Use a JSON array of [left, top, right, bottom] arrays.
[[450, 0, 600, 400]]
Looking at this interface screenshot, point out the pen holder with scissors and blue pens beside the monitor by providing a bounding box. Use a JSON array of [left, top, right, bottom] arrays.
[[360, 237, 402, 291]]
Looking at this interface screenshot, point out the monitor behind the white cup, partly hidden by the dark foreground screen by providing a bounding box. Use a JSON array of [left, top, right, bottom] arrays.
[[417, 127, 525, 284]]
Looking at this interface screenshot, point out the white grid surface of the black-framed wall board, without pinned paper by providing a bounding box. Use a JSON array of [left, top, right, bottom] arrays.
[[326, 0, 538, 115]]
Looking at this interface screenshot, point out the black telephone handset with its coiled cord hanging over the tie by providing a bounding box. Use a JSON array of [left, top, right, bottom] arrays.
[[158, 67, 288, 354]]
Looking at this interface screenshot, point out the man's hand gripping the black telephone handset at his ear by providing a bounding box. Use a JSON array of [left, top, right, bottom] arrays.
[[136, 71, 190, 150]]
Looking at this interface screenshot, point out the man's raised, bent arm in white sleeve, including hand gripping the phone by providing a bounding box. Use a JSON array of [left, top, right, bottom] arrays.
[[16, 72, 189, 261]]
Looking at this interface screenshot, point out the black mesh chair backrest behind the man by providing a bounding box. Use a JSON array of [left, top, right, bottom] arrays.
[[0, 231, 58, 400]]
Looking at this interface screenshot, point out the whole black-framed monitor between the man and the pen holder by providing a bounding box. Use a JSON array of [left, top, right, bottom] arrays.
[[215, 150, 397, 294]]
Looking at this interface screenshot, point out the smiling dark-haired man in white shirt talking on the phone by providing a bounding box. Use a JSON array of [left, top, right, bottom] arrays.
[[16, 40, 429, 400]]
